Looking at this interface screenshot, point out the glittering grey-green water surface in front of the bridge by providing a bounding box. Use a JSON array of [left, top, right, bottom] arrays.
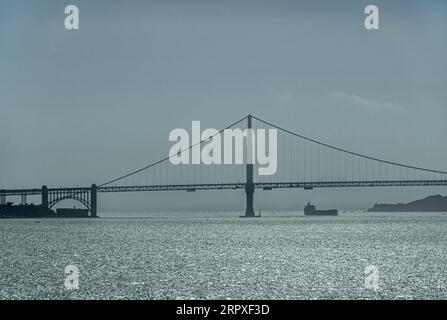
[[0, 211, 447, 299]]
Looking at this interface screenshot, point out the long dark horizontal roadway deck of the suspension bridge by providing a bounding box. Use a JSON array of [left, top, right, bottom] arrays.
[[0, 180, 447, 196]]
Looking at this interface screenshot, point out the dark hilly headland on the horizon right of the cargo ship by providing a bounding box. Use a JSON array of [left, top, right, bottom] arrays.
[[368, 195, 447, 212]]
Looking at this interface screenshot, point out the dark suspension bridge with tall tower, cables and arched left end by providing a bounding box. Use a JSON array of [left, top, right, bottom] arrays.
[[0, 115, 447, 217]]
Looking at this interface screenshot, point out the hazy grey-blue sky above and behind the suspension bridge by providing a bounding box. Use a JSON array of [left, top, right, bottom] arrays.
[[0, 0, 447, 211]]
